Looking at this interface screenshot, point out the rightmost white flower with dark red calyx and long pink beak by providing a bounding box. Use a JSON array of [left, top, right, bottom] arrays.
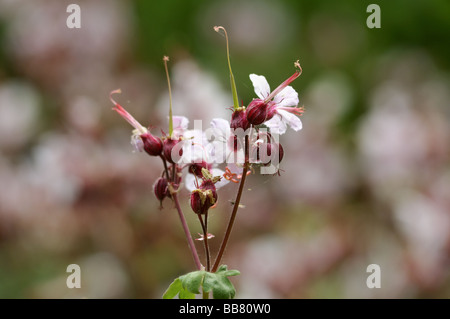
[[247, 61, 303, 134]]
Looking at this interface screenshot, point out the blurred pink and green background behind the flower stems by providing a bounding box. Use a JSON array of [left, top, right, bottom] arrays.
[[0, 0, 450, 298]]
